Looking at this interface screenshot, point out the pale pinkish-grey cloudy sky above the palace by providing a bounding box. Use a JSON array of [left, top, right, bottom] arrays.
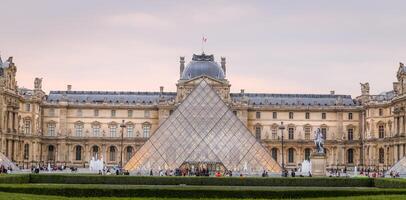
[[0, 0, 406, 97]]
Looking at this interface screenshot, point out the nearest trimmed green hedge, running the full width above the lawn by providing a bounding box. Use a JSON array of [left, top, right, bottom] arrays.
[[0, 184, 406, 199]]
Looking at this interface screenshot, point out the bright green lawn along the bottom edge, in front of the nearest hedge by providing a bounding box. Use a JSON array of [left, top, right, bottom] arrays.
[[0, 192, 406, 200]]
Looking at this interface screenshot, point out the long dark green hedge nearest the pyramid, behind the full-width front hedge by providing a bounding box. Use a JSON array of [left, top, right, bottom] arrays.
[[30, 174, 374, 187]]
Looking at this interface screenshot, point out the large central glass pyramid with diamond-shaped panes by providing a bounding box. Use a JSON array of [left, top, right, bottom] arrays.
[[124, 78, 281, 175]]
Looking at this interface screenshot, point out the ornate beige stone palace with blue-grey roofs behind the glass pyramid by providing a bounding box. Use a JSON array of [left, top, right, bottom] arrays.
[[0, 54, 406, 169]]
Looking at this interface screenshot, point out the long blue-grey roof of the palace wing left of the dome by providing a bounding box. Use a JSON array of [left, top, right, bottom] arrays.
[[46, 91, 176, 104]]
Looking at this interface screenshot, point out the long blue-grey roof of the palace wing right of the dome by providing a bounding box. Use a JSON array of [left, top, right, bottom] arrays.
[[231, 93, 358, 106]]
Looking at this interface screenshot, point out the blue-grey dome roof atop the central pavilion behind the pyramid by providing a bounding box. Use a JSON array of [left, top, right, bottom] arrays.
[[181, 53, 225, 80]]
